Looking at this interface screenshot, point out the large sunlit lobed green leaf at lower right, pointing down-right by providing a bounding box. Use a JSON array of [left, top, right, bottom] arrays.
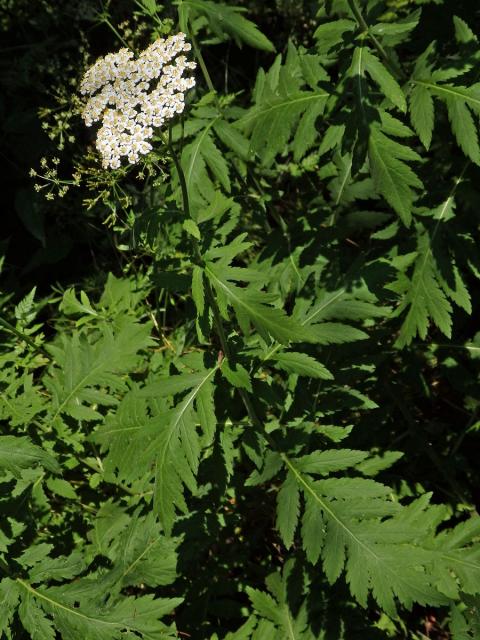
[[287, 461, 447, 615]]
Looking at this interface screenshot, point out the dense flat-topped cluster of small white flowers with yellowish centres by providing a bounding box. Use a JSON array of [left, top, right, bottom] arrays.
[[80, 33, 196, 169]]
